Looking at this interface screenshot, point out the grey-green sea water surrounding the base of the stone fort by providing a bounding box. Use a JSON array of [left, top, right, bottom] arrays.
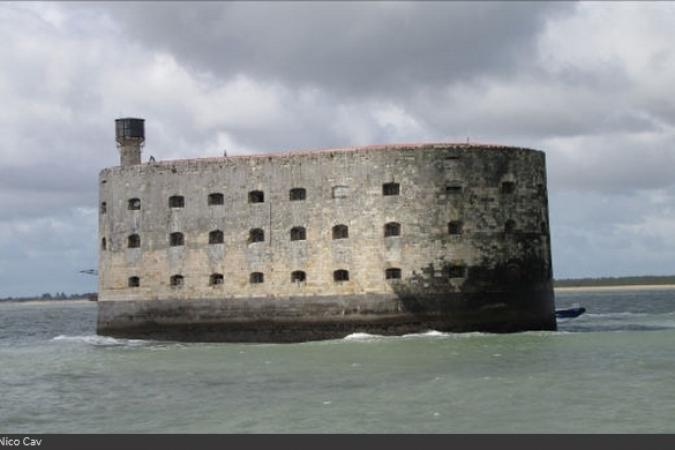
[[0, 290, 675, 433]]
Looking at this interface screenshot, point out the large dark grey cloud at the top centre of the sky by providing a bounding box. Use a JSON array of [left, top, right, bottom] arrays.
[[95, 2, 574, 96]]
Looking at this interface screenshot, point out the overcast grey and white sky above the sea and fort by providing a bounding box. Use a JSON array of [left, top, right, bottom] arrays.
[[0, 2, 675, 297]]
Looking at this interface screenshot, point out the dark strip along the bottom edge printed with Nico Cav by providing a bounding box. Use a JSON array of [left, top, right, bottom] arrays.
[[0, 434, 675, 450]]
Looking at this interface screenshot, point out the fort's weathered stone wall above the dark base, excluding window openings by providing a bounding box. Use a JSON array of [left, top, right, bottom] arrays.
[[99, 144, 555, 340]]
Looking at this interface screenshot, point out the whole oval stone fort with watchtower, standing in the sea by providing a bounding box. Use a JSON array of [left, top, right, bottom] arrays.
[[97, 118, 556, 342]]
